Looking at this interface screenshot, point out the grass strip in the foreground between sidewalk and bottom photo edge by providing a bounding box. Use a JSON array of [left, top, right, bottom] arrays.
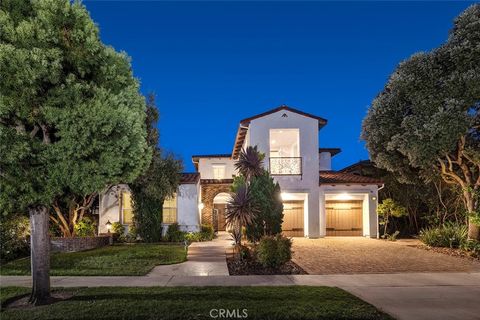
[[0, 286, 391, 320]]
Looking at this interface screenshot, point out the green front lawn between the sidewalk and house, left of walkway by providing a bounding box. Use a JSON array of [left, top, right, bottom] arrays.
[[0, 244, 187, 276]]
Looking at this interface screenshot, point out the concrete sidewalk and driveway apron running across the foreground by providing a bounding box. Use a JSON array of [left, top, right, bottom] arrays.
[[0, 273, 480, 320]]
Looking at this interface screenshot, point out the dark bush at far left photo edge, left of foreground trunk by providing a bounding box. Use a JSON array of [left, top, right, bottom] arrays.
[[0, 216, 30, 262]]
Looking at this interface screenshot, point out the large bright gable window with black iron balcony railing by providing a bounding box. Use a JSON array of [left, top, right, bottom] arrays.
[[270, 129, 302, 175]]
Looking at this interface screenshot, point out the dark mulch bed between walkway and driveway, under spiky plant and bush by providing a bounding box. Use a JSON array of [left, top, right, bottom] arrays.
[[227, 256, 307, 276]]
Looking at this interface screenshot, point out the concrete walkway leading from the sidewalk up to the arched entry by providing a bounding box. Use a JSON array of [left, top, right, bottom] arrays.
[[147, 232, 232, 277]]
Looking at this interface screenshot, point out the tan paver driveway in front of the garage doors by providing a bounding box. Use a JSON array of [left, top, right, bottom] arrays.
[[293, 237, 480, 274]]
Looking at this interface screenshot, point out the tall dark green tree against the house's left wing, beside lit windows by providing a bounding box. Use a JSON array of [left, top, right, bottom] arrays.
[[130, 94, 183, 242]]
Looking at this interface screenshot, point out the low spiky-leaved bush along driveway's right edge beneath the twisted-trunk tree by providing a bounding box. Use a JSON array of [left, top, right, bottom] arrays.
[[420, 223, 468, 248]]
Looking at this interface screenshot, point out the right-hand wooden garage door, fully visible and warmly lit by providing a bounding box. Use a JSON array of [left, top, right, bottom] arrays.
[[326, 201, 363, 236]]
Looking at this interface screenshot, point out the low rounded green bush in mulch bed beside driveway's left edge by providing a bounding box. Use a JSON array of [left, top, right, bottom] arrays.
[[257, 235, 292, 269]]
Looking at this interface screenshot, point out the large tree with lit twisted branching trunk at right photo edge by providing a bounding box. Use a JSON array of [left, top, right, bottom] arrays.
[[362, 5, 480, 239]]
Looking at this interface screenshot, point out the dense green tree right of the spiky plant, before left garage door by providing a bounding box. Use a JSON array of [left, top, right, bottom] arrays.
[[246, 170, 283, 242]]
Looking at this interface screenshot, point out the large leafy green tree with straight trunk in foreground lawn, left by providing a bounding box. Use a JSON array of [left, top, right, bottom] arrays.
[[0, 0, 151, 304]]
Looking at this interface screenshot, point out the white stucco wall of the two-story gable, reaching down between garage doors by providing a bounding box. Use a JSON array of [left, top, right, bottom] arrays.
[[246, 110, 320, 238]]
